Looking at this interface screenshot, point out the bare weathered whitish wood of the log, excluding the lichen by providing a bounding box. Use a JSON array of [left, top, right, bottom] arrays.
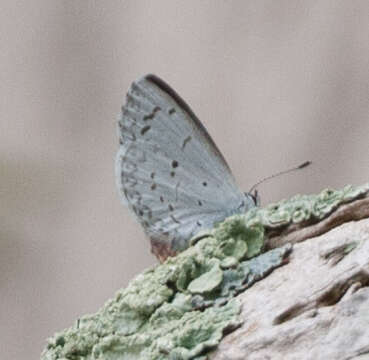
[[210, 215, 369, 360]]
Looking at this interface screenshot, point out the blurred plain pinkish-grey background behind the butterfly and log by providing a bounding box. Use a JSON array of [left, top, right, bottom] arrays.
[[0, 0, 369, 360]]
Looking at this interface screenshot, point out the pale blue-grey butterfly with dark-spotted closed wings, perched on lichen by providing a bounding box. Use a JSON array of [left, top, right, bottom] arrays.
[[116, 74, 257, 261]]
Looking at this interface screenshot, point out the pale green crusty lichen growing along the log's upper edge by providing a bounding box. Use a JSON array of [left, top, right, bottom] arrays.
[[42, 184, 369, 360]]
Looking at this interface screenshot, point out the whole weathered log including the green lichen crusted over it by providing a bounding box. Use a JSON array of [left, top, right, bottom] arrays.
[[42, 190, 369, 360]]
